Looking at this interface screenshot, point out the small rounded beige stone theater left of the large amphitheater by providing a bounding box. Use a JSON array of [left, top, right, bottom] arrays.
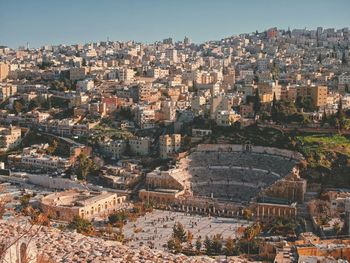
[[41, 190, 126, 221]]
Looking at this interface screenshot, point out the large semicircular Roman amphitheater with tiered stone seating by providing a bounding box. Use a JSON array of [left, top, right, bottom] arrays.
[[140, 143, 306, 217]]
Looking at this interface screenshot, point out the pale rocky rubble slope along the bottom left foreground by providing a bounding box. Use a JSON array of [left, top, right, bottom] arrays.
[[0, 221, 253, 263]]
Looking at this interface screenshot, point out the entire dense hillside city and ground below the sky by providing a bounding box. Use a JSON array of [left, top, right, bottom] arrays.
[[0, 13, 350, 263]]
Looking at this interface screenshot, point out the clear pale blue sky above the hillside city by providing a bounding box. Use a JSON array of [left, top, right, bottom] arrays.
[[0, 0, 350, 48]]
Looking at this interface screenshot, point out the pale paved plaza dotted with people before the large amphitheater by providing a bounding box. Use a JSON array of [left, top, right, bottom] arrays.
[[124, 210, 249, 252]]
